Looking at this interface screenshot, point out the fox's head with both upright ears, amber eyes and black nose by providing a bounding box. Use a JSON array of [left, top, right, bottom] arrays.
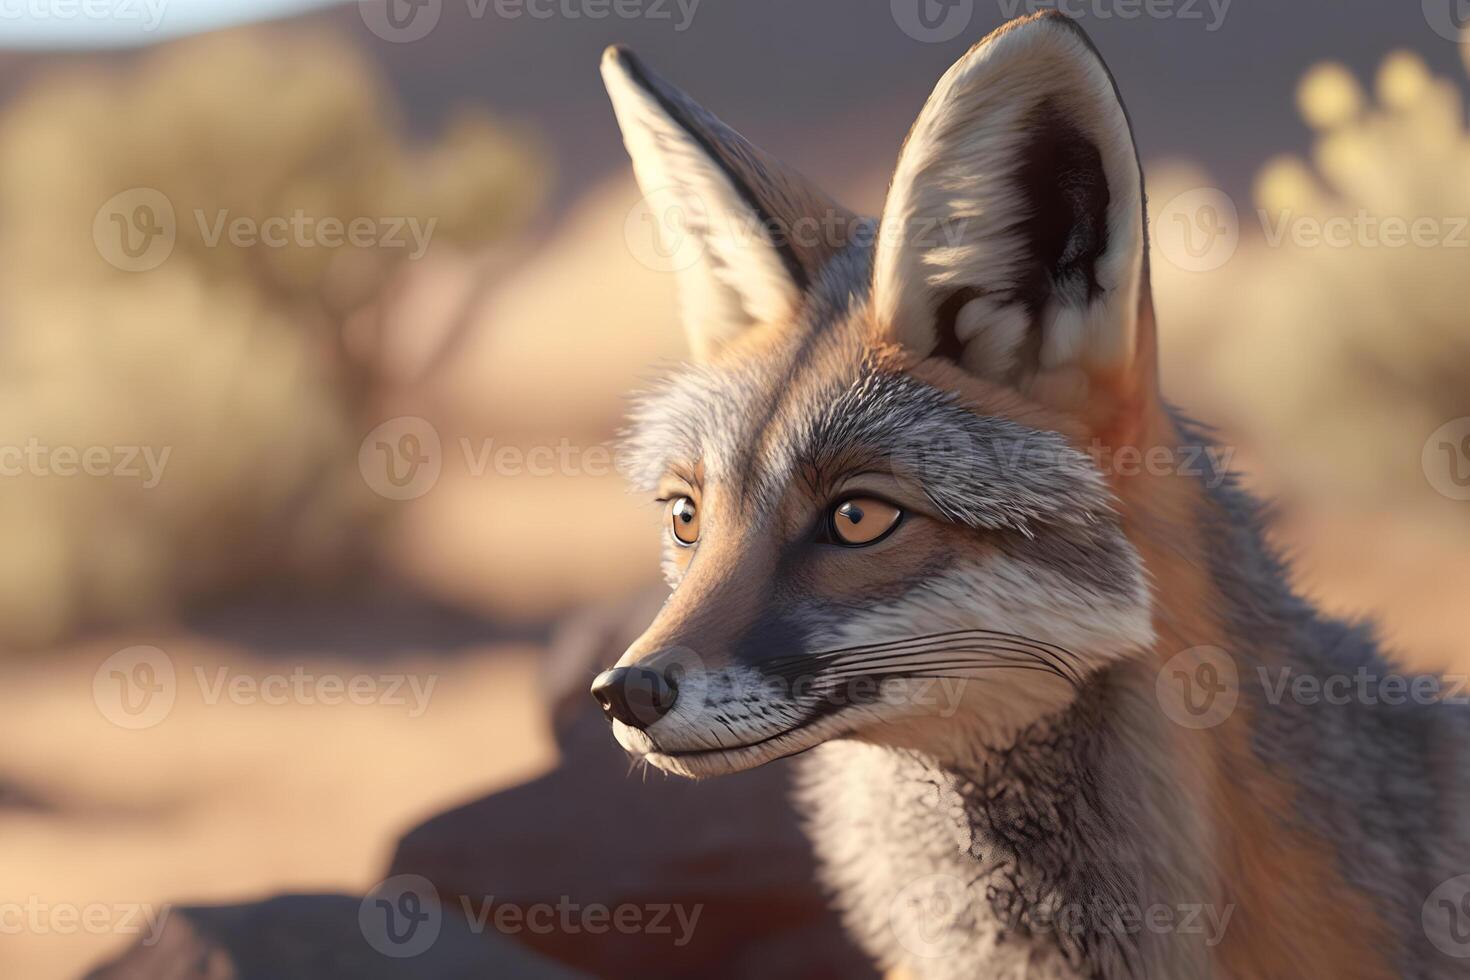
[[592, 15, 1166, 776]]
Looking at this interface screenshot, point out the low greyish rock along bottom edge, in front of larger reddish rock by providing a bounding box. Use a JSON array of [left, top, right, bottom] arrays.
[[87, 895, 585, 980]]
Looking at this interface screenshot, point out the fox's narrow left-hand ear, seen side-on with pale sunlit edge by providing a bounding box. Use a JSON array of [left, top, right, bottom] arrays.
[[603, 47, 854, 360]]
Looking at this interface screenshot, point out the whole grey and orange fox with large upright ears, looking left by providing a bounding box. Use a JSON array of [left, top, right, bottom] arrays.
[[592, 12, 1470, 980]]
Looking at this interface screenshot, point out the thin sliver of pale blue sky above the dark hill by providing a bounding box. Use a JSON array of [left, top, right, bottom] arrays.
[[0, 0, 338, 48]]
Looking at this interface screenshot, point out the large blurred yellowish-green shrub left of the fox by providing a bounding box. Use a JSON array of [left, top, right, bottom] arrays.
[[0, 31, 538, 645]]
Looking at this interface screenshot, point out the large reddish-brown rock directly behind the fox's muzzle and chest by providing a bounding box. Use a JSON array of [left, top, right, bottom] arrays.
[[390, 587, 878, 980]]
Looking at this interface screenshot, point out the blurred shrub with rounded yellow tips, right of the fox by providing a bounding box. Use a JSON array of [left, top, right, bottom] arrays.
[[1151, 45, 1470, 517]]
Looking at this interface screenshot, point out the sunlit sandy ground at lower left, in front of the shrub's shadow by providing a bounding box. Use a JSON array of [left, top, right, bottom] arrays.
[[0, 632, 554, 980]]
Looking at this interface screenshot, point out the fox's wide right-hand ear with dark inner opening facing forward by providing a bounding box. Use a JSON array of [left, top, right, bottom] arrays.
[[873, 13, 1155, 437]]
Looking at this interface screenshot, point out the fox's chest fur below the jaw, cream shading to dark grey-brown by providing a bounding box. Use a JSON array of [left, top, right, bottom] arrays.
[[798, 681, 1211, 980]]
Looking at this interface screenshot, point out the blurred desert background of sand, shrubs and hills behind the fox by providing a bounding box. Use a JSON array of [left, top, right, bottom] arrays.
[[0, 0, 1470, 979]]
